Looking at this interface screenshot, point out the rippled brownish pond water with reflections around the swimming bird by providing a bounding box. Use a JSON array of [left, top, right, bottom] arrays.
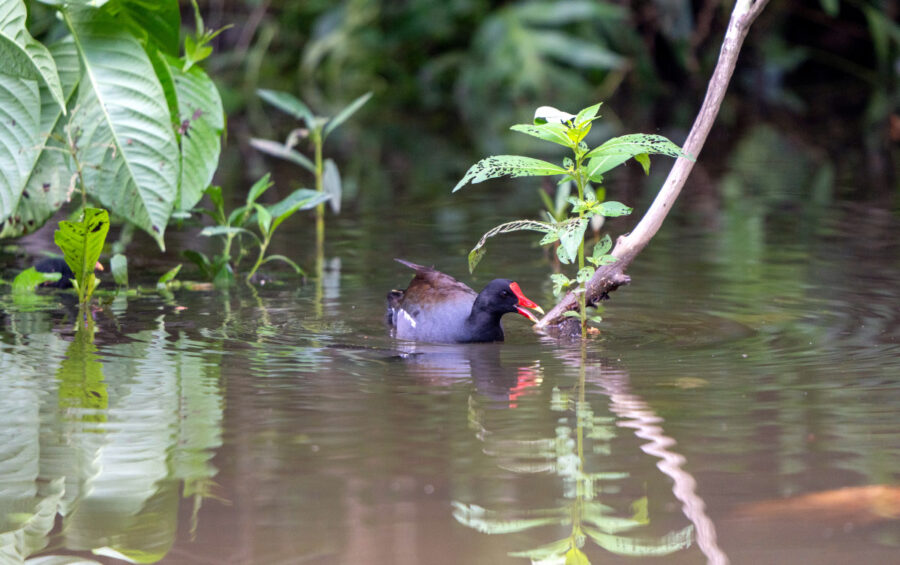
[[0, 180, 900, 565]]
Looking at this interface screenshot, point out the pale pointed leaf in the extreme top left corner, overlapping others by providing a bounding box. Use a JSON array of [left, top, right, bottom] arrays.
[[0, 0, 66, 113]]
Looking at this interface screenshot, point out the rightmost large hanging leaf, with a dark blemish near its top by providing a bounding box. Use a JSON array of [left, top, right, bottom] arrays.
[[166, 57, 225, 210]]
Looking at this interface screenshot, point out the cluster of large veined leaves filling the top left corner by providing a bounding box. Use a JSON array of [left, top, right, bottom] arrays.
[[0, 0, 224, 248]]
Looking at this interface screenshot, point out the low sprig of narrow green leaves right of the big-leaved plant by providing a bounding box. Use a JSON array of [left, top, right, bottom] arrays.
[[184, 174, 328, 287]]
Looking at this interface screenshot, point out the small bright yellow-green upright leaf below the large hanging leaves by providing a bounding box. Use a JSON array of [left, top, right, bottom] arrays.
[[53, 208, 109, 298]]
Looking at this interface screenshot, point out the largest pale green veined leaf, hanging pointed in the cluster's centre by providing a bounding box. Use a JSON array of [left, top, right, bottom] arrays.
[[63, 10, 180, 249]]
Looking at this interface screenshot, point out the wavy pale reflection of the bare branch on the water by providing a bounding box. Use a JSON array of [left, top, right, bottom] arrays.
[[596, 371, 728, 565]]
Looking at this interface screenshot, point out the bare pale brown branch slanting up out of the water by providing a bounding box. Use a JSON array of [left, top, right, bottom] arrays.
[[534, 0, 769, 335]]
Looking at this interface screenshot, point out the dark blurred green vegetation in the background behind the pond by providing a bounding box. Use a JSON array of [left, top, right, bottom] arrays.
[[30, 0, 900, 218]]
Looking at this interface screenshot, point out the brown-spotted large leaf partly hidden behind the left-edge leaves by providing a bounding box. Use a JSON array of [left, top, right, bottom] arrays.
[[0, 39, 81, 238]]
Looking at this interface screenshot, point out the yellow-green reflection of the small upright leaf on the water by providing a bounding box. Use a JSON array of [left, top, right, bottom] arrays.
[[56, 329, 109, 422]]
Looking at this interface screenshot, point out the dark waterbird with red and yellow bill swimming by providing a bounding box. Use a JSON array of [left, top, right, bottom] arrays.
[[387, 259, 544, 343]]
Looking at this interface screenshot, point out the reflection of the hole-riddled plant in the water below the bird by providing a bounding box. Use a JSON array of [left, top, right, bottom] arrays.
[[453, 380, 694, 565]]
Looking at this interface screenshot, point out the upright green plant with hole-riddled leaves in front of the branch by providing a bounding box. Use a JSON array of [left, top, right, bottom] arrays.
[[453, 103, 686, 337]]
